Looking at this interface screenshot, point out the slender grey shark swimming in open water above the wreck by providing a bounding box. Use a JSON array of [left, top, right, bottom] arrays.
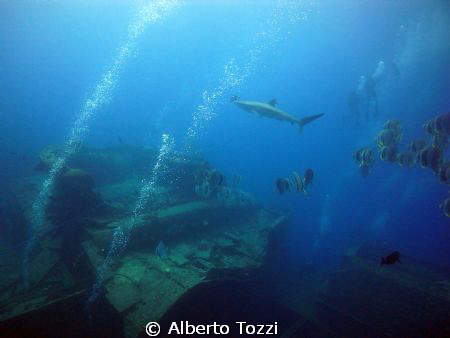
[[230, 96, 324, 132]]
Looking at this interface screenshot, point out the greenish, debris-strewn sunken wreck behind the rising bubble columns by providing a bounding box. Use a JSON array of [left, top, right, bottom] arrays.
[[0, 145, 284, 337]]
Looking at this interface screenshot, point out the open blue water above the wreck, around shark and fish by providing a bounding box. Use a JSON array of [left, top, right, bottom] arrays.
[[0, 1, 450, 278]]
